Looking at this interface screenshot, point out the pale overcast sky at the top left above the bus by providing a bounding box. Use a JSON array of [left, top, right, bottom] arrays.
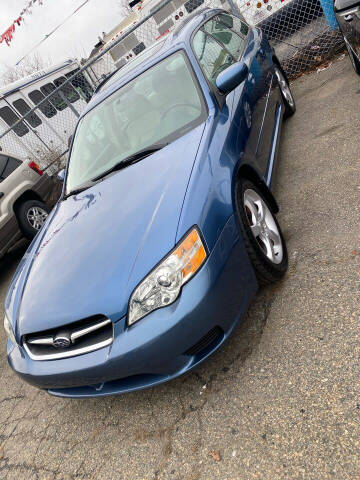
[[0, 0, 122, 74]]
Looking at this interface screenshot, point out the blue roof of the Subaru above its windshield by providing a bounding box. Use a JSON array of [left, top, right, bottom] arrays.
[[81, 8, 225, 117]]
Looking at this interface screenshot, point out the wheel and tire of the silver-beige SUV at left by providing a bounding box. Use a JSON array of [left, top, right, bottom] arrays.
[[16, 200, 50, 240]]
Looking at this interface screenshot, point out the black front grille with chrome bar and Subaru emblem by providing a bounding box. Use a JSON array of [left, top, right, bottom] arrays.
[[23, 315, 114, 360]]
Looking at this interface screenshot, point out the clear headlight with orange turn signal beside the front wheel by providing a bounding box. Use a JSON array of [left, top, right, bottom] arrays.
[[128, 228, 207, 325]]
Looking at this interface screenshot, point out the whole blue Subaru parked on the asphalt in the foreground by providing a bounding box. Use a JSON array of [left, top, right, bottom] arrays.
[[4, 9, 295, 398]]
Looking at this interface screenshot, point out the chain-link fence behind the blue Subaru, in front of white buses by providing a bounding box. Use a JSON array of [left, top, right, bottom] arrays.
[[0, 0, 343, 175]]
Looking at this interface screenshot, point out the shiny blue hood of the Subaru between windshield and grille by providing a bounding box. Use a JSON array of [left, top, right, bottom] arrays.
[[6, 124, 204, 339]]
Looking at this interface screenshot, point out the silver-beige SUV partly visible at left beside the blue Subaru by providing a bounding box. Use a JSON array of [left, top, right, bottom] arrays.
[[0, 152, 55, 258]]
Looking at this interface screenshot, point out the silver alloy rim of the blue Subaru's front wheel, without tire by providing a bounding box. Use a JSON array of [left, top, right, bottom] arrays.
[[244, 189, 284, 264]]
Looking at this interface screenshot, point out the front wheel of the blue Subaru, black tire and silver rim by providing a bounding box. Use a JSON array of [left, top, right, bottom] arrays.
[[235, 179, 288, 285]]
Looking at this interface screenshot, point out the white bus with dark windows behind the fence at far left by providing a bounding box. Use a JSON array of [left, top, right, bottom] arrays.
[[0, 60, 94, 159]]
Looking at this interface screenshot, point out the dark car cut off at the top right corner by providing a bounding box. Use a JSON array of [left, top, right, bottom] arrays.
[[334, 0, 360, 75]]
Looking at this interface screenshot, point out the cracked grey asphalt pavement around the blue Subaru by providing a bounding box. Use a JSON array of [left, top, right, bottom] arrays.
[[0, 57, 360, 480]]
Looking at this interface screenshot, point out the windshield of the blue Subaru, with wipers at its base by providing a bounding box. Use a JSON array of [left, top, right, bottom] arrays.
[[66, 51, 206, 194]]
